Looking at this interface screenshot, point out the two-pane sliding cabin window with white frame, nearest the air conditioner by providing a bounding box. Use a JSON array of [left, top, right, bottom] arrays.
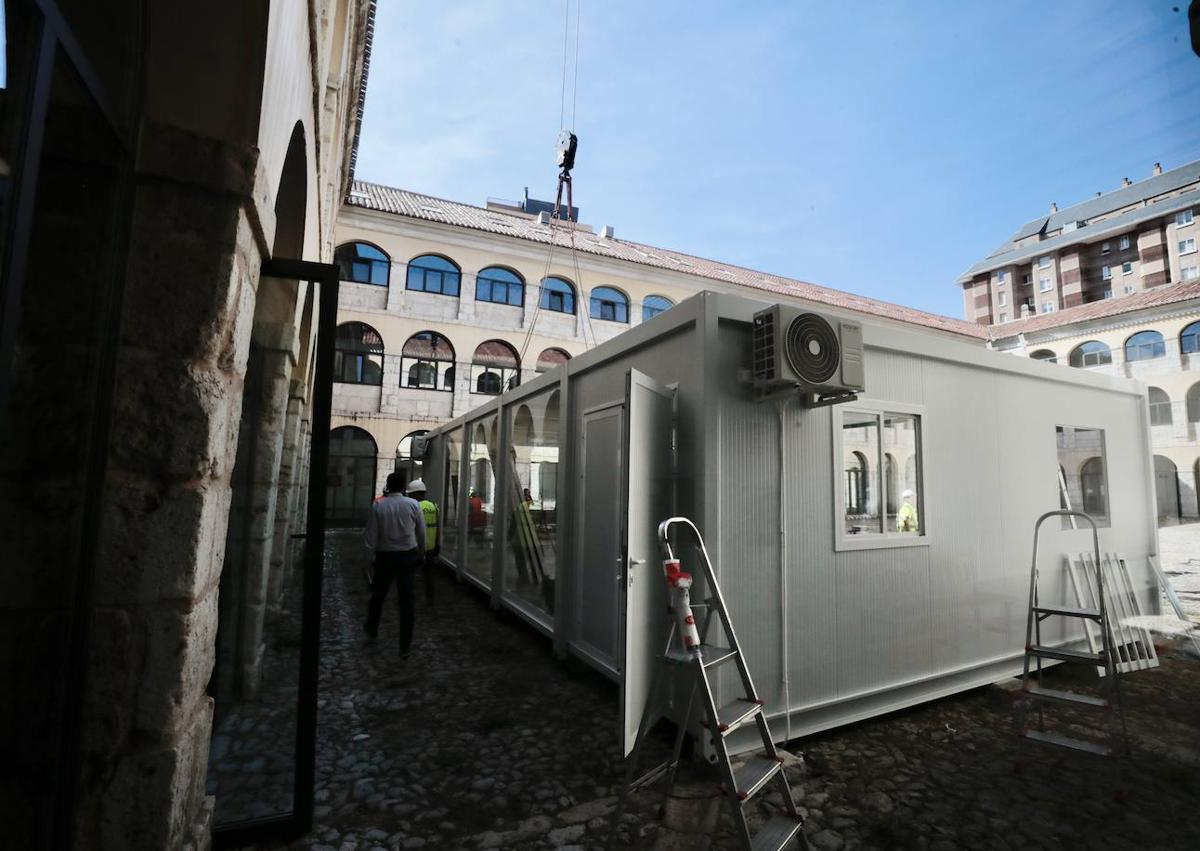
[[833, 403, 928, 550]]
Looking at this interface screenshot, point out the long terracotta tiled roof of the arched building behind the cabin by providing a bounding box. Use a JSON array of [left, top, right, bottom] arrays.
[[346, 180, 988, 340]]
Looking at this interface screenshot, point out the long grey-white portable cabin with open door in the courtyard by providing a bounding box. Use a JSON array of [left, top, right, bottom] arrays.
[[425, 293, 1158, 750]]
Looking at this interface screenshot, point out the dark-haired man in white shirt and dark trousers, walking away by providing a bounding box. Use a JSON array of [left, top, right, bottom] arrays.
[[362, 473, 425, 659]]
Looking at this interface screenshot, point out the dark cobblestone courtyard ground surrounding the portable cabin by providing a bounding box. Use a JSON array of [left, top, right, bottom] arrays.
[[270, 534, 1200, 851]]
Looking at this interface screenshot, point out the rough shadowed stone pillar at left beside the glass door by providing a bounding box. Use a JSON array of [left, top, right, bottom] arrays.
[[76, 122, 269, 847]]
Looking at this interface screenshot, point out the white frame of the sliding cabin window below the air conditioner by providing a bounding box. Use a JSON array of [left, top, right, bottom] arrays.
[[829, 398, 932, 552]]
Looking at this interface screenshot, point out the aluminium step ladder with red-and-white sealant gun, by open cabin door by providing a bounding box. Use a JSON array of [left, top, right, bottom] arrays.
[[608, 517, 809, 851]]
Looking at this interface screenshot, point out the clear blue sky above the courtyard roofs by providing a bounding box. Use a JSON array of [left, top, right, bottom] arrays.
[[356, 0, 1200, 316]]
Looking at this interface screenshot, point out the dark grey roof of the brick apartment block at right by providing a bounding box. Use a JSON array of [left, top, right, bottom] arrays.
[[959, 160, 1200, 283]]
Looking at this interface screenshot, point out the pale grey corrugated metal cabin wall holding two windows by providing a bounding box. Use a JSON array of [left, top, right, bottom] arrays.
[[703, 314, 1154, 736]]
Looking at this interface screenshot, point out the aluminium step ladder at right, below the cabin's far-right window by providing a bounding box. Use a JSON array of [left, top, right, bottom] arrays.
[[1015, 509, 1129, 777]]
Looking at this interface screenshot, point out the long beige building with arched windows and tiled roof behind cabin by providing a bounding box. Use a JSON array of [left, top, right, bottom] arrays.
[[329, 182, 985, 511]]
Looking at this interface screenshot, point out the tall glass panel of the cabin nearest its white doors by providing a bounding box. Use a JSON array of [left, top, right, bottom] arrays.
[[504, 389, 559, 617]]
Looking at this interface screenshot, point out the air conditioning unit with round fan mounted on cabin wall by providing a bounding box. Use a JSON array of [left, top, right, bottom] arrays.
[[754, 305, 865, 407]]
